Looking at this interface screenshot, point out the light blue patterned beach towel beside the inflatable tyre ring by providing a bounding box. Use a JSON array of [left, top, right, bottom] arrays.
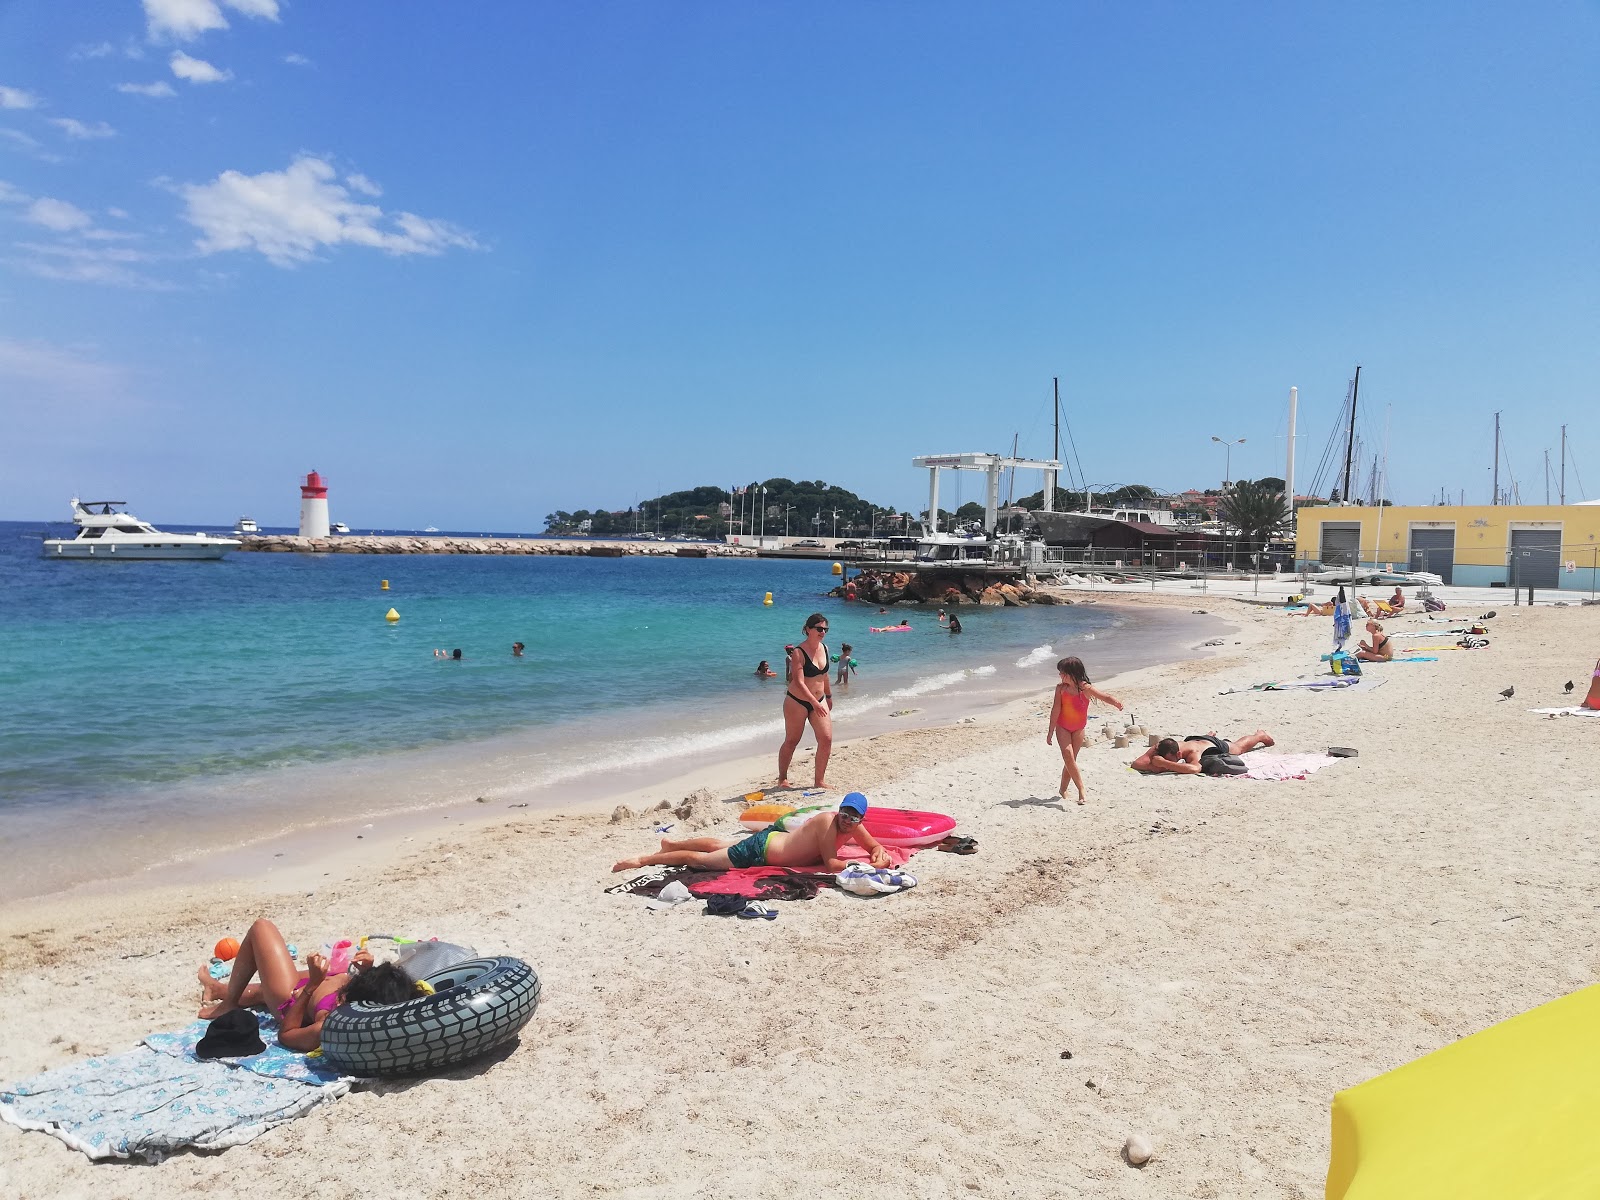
[[0, 1014, 352, 1163]]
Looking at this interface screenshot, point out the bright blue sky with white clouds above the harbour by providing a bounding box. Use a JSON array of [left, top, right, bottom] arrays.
[[0, 0, 1600, 530]]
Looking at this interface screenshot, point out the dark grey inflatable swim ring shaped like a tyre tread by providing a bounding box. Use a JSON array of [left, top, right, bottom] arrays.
[[322, 958, 539, 1075]]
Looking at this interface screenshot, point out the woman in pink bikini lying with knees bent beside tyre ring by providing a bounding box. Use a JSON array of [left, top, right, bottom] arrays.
[[200, 918, 416, 1054]]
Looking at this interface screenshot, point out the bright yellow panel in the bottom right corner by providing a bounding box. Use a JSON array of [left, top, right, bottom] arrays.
[[1326, 986, 1600, 1200]]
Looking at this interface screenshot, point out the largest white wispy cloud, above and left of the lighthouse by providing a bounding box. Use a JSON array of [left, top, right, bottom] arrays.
[[178, 155, 477, 267]]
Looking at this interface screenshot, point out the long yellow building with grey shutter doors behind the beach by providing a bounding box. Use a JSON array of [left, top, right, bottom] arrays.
[[1294, 504, 1600, 592]]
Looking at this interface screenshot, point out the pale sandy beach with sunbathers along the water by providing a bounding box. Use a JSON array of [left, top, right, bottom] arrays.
[[0, 595, 1600, 1200]]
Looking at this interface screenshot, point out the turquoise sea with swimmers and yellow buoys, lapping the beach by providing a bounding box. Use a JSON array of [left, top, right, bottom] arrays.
[[0, 522, 1197, 899]]
